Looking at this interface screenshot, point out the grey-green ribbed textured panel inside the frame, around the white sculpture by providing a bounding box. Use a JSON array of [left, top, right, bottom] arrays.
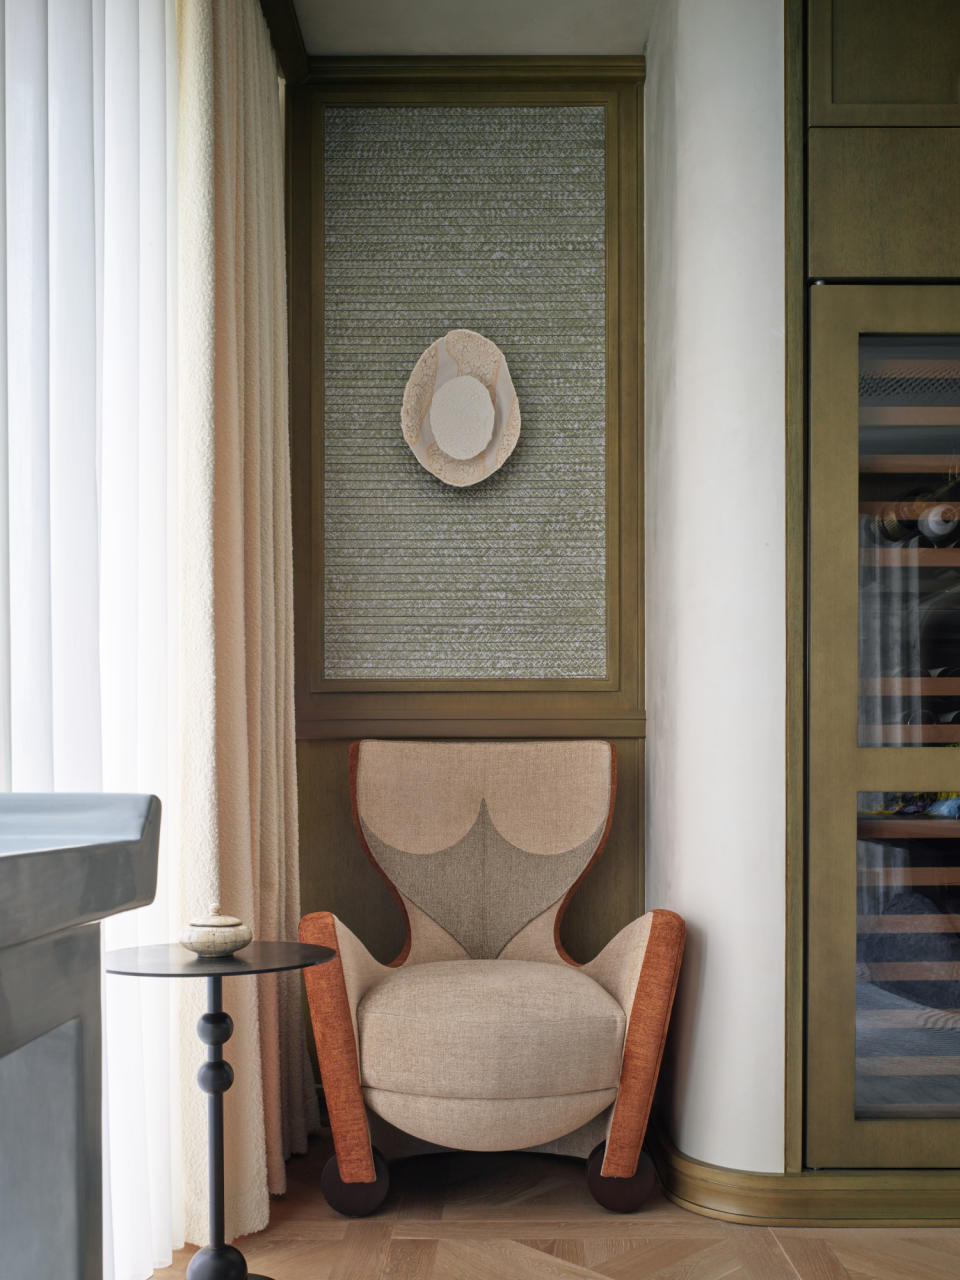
[[324, 106, 607, 680]]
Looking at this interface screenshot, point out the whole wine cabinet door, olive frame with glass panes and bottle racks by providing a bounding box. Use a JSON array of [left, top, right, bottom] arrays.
[[806, 284, 960, 1169]]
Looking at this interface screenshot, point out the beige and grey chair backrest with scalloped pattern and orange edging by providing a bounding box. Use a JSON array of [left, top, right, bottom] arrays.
[[351, 740, 616, 964]]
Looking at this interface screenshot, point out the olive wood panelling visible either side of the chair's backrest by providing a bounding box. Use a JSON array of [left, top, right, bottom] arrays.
[[297, 739, 644, 964]]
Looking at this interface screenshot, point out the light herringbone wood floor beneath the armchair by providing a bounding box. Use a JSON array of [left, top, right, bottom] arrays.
[[156, 1144, 960, 1280]]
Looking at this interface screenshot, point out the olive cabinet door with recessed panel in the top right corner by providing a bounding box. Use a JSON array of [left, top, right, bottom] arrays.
[[809, 0, 960, 124]]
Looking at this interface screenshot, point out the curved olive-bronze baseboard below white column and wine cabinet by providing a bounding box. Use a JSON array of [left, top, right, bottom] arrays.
[[648, 1133, 960, 1226]]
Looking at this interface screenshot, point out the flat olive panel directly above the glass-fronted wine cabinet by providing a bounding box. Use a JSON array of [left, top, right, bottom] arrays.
[[809, 128, 960, 279]]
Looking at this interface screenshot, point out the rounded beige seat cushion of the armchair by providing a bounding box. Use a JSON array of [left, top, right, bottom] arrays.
[[357, 960, 625, 1098]]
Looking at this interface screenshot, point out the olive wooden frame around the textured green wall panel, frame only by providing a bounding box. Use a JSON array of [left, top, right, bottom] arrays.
[[289, 58, 644, 739]]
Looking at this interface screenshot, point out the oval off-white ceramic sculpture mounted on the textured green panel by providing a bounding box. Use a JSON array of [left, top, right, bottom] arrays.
[[401, 329, 520, 488]]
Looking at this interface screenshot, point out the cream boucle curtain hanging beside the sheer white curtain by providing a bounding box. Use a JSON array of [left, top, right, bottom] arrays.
[[178, 0, 316, 1242]]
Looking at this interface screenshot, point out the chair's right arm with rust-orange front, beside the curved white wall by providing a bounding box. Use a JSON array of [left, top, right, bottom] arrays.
[[582, 910, 686, 1178]]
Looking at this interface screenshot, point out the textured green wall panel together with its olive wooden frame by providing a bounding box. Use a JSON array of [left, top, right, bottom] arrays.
[[291, 59, 643, 739]]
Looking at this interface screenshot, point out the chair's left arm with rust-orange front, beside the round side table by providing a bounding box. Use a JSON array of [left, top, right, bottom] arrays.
[[300, 911, 390, 1183]]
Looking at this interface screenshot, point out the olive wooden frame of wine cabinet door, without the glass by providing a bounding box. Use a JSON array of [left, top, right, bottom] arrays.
[[806, 284, 960, 1172]]
